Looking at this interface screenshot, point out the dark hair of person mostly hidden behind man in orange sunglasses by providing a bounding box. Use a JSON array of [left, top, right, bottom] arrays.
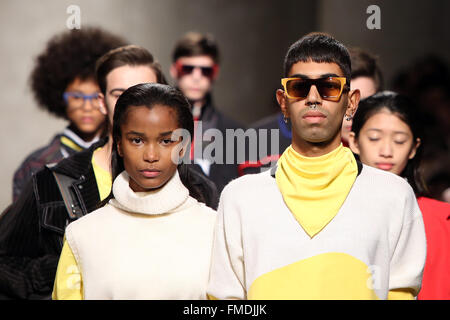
[[349, 47, 384, 92]]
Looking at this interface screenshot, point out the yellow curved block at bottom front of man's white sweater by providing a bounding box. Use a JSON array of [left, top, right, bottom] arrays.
[[248, 252, 378, 300]]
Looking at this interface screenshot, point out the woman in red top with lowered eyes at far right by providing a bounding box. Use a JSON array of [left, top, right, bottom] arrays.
[[349, 91, 450, 299]]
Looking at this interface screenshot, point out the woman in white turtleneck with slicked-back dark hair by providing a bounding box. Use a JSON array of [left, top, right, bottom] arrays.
[[53, 84, 216, 299]]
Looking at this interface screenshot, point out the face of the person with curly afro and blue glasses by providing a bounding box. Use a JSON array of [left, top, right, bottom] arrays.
[[66, 78, 106, 141]]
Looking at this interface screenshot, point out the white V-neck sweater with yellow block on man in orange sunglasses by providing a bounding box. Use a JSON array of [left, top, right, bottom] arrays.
[[208, 166, 426, 300]]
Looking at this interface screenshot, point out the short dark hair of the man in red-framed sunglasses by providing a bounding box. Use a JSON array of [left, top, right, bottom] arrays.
[[172, 31, 220, 64]]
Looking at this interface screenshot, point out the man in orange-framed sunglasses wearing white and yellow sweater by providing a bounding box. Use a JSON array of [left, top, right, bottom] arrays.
[[208, 33, 426, 300]]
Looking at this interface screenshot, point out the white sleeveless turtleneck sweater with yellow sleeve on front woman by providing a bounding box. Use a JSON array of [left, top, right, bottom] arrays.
[[53, 171, 216, 300]]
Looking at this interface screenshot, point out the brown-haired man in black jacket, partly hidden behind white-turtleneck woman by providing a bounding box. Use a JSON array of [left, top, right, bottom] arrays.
[[0, 45, 218, 299]]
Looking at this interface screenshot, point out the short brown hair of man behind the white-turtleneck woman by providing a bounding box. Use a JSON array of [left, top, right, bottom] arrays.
[[96, 45, 167, 94]]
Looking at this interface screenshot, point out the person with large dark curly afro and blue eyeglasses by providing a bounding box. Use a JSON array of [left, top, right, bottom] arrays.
[[13, 27, 126, 201]]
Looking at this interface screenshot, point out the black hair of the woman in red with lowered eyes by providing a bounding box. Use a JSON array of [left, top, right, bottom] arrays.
[[352, 91, 428, 196]]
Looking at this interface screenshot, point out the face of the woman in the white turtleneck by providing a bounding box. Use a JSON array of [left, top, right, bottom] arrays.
[[117, 105, 183, 192]]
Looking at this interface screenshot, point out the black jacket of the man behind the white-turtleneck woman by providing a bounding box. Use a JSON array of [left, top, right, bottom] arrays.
[[0, 140, 218, 299]]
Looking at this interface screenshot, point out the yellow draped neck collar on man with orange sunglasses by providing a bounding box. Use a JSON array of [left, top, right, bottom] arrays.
[[275, 144, 358, 238]]
